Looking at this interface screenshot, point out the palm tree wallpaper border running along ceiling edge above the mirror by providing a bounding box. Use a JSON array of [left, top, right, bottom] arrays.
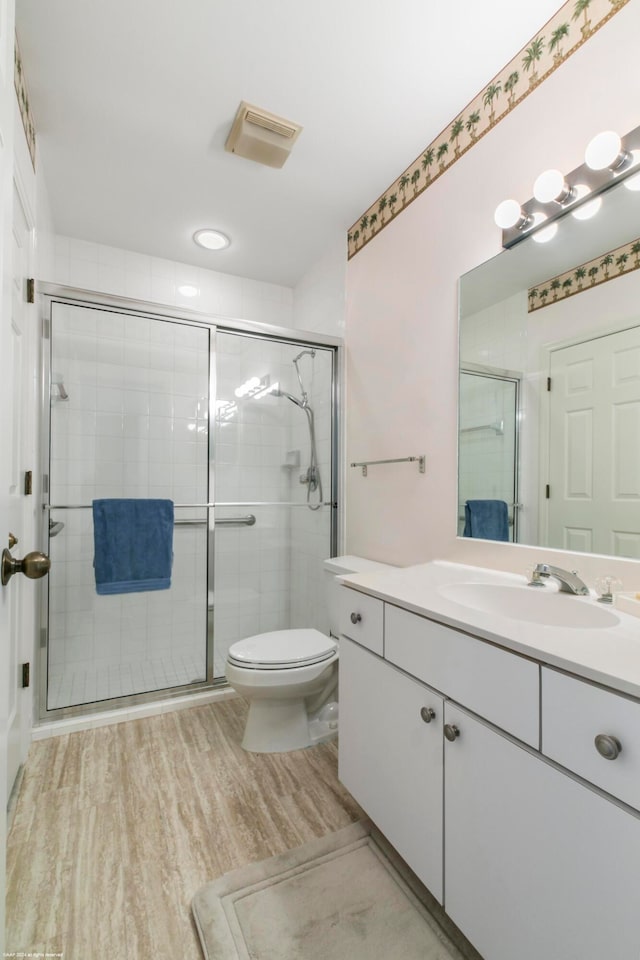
[[347, 0, 629, 260]]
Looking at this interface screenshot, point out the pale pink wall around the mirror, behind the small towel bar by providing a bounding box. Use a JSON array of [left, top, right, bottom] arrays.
[[346, 2, 640, 589]]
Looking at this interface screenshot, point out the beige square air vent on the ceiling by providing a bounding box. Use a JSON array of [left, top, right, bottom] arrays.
[[224, 100, 302, 167]]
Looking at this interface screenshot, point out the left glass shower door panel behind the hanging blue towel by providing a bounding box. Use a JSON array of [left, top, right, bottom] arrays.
[[45, 301, 212, 710]]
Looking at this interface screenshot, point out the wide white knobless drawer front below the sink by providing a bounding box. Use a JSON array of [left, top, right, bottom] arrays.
[[385, 604, 540, 749]]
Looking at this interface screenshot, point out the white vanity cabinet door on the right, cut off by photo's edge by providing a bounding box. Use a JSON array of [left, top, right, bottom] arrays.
[[444, 703, 640, 960]]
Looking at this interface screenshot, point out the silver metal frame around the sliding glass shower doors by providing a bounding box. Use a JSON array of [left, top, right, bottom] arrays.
[[34, 283, 343, 722]]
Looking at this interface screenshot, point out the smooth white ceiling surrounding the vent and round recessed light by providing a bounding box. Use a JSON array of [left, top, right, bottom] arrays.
[[16, 0, 560, 286]]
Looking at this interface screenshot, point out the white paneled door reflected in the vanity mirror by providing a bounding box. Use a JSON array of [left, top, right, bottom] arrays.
[[546, 327, 640, 559]]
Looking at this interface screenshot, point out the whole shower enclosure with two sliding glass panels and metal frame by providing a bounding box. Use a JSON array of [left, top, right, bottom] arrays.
[[40, 296, 337, 718]]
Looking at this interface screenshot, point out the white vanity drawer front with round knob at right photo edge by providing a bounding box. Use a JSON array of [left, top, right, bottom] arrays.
[[542, 667, 640, 809]]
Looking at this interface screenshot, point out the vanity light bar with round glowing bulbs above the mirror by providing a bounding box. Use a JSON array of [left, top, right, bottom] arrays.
[[494, 121, 640, 249]]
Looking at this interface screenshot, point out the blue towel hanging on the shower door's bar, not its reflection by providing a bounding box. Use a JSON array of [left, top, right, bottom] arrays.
[[93, 499, 173, 595]]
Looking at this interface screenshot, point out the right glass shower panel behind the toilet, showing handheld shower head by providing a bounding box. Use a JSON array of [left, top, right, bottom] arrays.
[[212, 329, 335, 677]]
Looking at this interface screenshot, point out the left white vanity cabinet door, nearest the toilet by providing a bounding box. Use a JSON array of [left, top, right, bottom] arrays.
[[339, 637, 443, 902]]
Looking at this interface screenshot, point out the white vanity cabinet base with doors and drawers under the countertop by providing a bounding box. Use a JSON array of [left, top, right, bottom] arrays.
[[339, 588, 640, 960]]
